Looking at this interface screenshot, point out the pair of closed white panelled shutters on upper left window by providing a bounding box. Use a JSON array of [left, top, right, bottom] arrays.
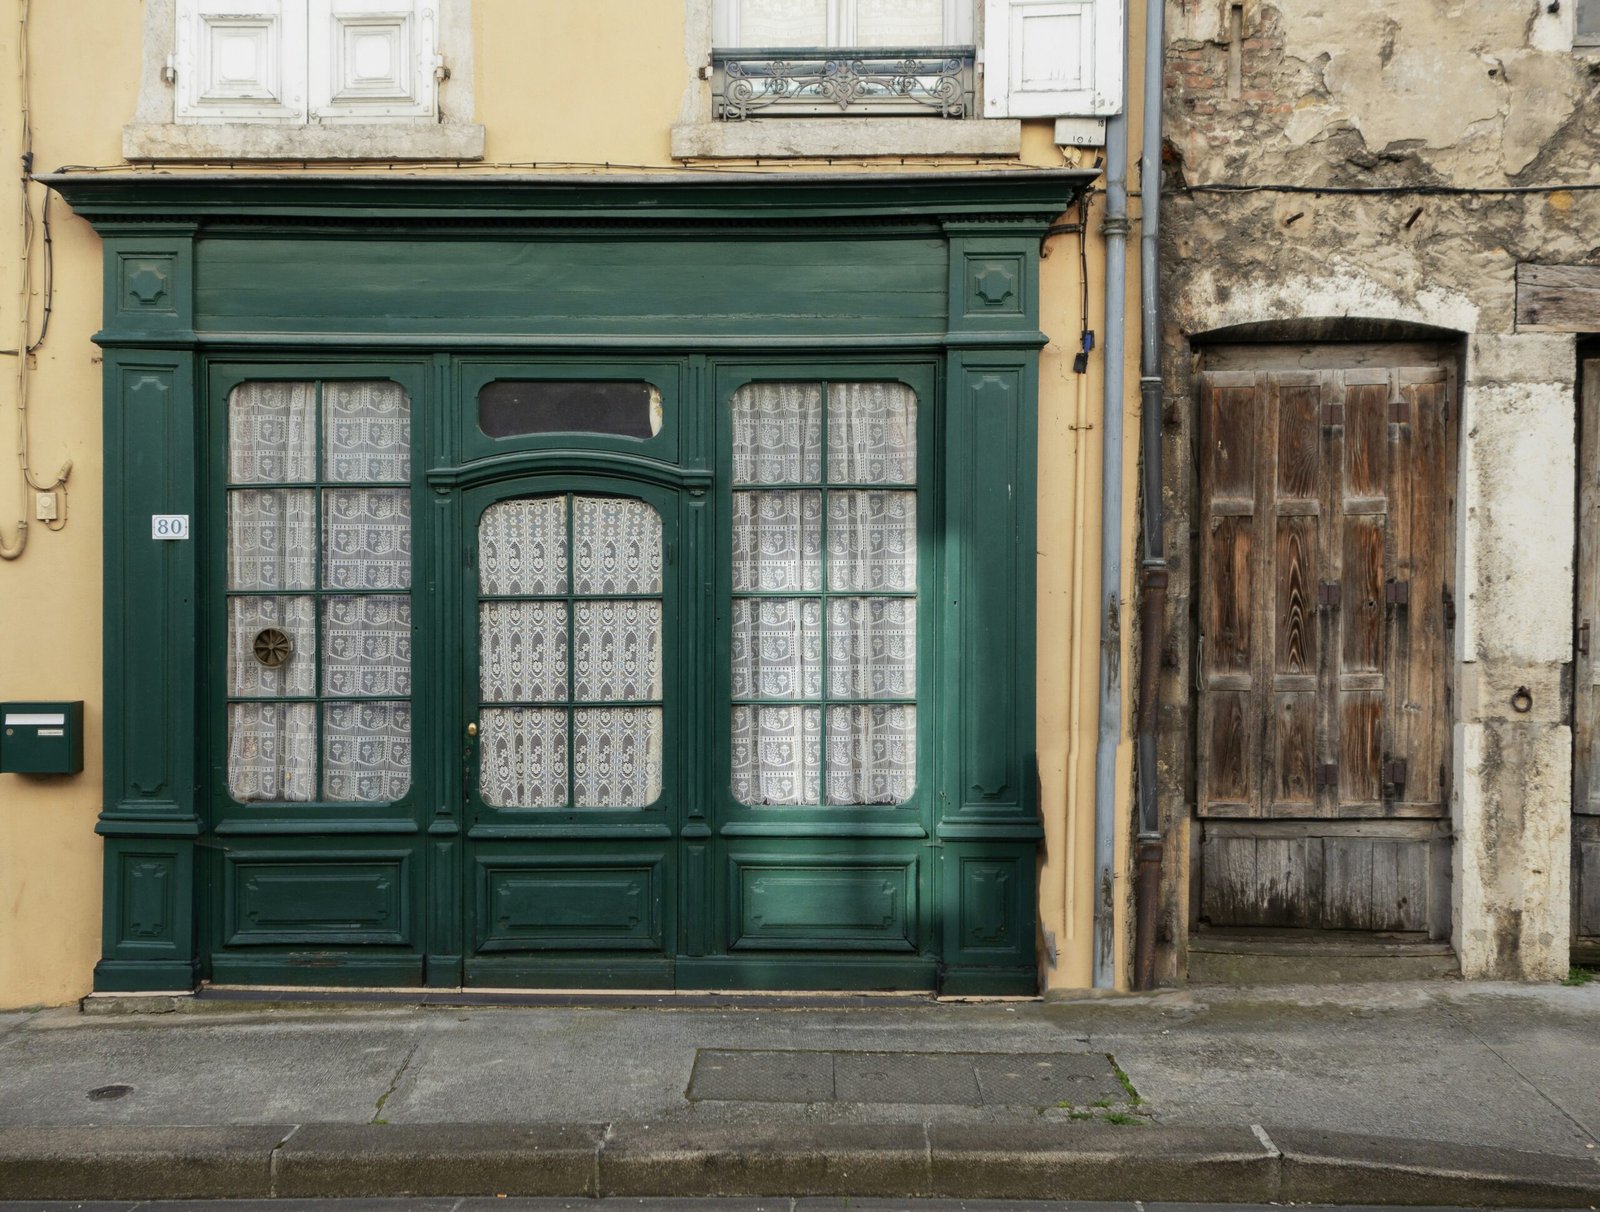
[[173, 0, 443, 123]]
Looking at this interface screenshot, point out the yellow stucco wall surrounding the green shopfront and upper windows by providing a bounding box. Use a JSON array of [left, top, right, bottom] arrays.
[[0, 0, 1139, 1007]]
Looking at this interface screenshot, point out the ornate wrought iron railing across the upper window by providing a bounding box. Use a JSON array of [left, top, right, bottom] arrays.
[[710, 46, 976, 122]]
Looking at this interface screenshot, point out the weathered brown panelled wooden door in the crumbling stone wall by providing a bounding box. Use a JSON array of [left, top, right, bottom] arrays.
[[1197, 347, 1451, 937]]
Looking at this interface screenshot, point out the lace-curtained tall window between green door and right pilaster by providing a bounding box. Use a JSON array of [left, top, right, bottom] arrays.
[[731, 382, 917, 804]]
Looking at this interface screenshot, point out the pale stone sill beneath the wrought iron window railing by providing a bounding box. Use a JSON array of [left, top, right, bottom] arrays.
[[672, 117, 1022, 160]]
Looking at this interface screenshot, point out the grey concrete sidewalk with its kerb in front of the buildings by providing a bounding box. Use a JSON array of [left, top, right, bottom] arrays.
[[0, 982, 1600, 1207]]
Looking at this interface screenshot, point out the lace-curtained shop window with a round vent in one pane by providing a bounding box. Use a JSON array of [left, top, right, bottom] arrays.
[[227, 382, 411, 803]]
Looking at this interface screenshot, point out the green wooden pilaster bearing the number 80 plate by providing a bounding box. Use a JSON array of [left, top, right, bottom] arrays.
[[94, 225, 205, 990]]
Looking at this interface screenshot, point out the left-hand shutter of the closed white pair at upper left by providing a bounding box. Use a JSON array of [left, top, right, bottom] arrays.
[[173, 0, 306, 122]]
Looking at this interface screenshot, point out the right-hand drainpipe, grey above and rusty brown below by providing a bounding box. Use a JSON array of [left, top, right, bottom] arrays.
[[1133, 0, 1166, 990]]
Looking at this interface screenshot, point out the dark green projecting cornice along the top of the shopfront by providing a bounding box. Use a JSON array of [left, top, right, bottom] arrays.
[[37, 168, 1098, 230]]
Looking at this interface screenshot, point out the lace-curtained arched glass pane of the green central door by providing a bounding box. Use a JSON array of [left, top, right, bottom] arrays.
[[478, 496, 664, 807]]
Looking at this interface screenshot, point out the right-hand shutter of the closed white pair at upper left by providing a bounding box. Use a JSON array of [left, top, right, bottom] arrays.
[[307, 0, 438, 122]]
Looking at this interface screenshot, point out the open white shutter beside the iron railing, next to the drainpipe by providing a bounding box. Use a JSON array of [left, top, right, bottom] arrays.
[[984, 0, 1123, 118]]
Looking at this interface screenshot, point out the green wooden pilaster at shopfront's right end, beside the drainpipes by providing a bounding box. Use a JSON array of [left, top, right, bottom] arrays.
[[938, 221, 1043, 993]]
